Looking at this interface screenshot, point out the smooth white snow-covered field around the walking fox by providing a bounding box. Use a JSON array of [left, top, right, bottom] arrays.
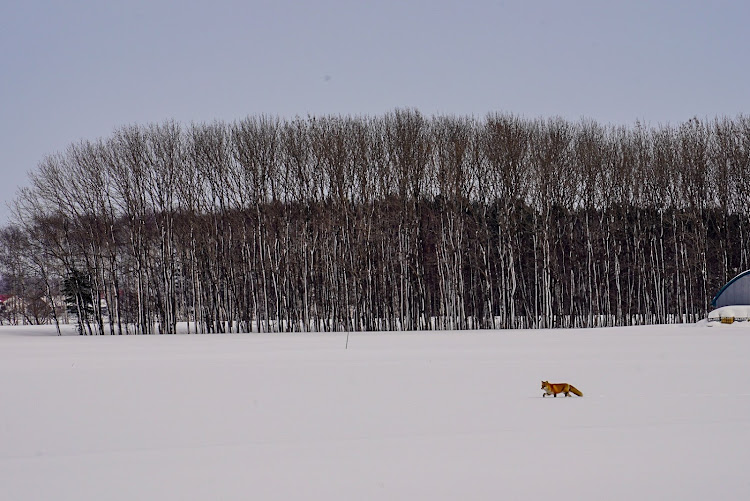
[[0, 324, 750, 501]]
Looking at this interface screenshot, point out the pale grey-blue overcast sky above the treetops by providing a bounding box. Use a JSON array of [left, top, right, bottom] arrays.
[[0, 0, 750, 220]]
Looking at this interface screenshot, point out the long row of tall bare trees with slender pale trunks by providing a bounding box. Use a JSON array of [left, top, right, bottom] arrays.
[[0, 110, 750, 334]]
